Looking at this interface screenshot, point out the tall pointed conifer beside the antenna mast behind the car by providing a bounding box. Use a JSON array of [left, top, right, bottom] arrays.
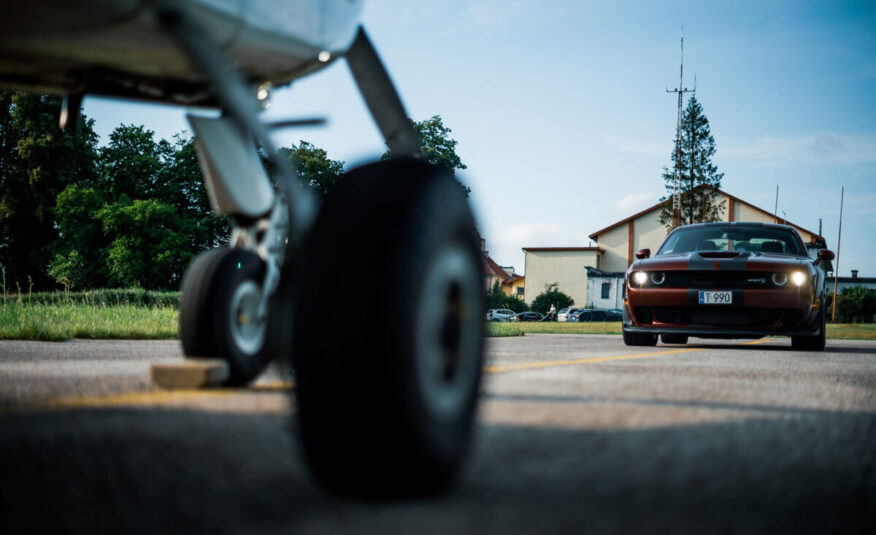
[[660, 96, 724, 229]]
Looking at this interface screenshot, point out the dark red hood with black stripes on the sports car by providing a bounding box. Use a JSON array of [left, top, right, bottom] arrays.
[[630, 251, 812, 271]]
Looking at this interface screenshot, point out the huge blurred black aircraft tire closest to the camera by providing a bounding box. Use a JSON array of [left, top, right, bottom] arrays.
[[269, 159, 486, 498]]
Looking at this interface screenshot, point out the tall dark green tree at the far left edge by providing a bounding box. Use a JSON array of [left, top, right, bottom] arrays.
[[0, 92, 97, 290]]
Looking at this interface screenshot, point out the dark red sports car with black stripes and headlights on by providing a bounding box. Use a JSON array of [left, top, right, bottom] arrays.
[[623, 223, 834, 351]]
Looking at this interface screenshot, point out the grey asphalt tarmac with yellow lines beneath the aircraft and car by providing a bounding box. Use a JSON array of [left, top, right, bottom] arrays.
[[0, 335, 876, 534]]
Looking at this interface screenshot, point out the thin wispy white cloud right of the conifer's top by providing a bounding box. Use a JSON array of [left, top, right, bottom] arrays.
[[718, 132, 876, 167]]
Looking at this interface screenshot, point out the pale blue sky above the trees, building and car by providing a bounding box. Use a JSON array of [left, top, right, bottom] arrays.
[[85, 0, 876, 277]]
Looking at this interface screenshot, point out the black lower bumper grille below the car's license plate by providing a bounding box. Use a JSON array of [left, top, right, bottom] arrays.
[[635, 307, 800, 327]]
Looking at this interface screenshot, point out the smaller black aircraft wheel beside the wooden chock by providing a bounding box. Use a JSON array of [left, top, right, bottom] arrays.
[[179, 247, 269, 386]]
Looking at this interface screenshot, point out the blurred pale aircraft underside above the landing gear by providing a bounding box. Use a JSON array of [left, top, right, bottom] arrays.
[[0, 0, 362, 106]]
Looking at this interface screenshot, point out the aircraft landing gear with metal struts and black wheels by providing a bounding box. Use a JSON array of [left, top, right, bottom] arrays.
[[162, 11, 486, 497]]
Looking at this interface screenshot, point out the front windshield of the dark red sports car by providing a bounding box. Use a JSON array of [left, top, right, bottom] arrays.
[[657, 226, 806, 256]]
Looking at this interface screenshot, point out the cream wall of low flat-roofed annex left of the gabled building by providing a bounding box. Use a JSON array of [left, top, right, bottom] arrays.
[[525, 250, 598, 306]]
